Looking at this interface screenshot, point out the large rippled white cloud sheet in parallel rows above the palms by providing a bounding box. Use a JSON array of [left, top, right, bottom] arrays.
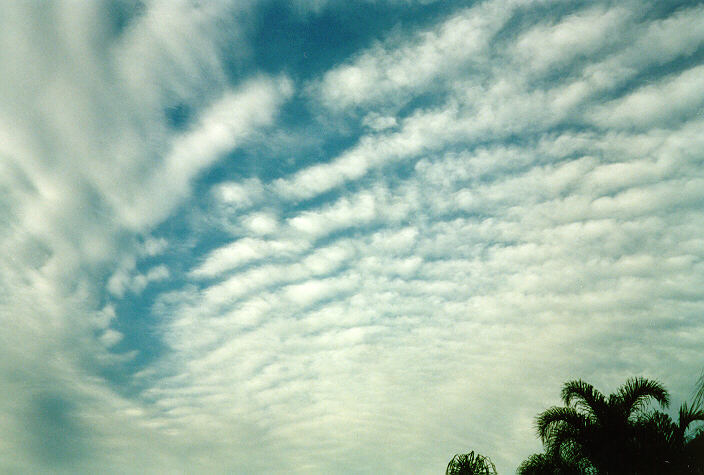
[[146, 1, 701, 471]]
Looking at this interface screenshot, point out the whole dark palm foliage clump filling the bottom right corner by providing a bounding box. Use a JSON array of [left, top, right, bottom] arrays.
[[518, 378, 704, 475]]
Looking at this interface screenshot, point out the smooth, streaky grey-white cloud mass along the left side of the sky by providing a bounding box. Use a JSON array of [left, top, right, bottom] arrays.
[[0, 2, 292, 473]]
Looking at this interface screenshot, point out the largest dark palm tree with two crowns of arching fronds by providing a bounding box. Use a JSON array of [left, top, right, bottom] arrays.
[[529, 378, 670, 474]]
